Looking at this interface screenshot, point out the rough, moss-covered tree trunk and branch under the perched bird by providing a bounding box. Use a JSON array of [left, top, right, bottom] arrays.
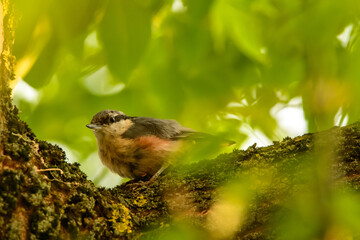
[[0, 0, 360, 239]]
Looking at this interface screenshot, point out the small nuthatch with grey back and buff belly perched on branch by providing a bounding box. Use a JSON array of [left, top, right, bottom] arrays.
[[86, 110, 206, 181]]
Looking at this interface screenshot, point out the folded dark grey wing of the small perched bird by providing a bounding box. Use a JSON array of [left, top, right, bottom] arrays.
[[122, 117, 206, 140]]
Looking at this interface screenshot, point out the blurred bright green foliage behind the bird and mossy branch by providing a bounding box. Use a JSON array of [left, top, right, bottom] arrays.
[[12, 0, 360, 239]]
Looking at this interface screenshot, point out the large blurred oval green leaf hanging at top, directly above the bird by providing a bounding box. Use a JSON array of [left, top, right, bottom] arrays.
[[98, 0, 151, 81]]
